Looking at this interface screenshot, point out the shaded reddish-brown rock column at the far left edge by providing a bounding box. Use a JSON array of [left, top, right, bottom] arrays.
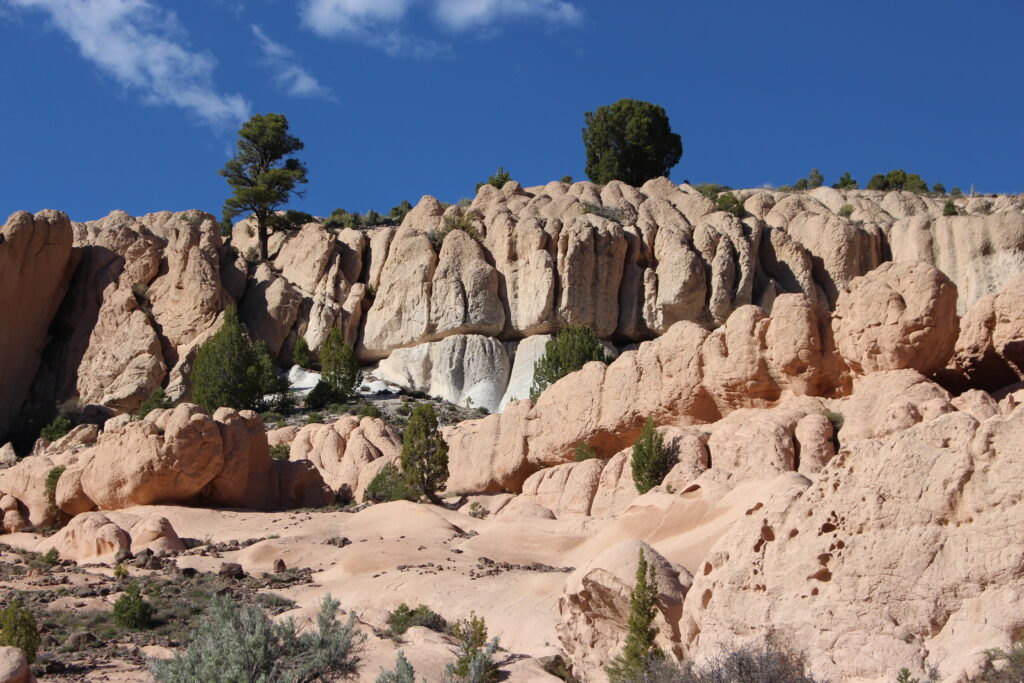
[[0, 211, 76, 440]]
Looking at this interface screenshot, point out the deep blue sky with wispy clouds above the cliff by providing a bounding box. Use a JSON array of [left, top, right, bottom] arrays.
[[0, 0, 1024, 220]]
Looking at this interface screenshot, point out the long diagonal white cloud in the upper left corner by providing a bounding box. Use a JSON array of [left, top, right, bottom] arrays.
[[7, 0, 250, 126]]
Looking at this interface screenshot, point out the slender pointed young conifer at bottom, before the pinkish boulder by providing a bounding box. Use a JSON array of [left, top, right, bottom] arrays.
[[604, 547, 665, 683]]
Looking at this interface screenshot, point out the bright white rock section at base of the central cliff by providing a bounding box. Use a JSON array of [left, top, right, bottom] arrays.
[[375, 335, 509, 412]]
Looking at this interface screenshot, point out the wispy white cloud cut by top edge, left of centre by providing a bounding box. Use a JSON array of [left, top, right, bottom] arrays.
[[299, 0, 583, 57]]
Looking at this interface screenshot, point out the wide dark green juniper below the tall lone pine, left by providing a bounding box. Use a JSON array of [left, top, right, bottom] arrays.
[[191, 306, 288, 415]]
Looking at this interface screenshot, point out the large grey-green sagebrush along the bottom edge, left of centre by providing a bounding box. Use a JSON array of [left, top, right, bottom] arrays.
[[152, 595, 362, 683]]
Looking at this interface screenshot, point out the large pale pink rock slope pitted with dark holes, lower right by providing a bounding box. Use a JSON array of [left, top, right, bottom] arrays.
[[682, 411, 1024, 680]]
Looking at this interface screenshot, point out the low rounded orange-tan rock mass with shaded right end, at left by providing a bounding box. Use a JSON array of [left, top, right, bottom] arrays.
[[0, 403, 334, 530]]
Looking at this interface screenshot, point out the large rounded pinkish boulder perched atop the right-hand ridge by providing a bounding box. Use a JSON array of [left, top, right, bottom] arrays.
[[833, 261, 957, 375]]
